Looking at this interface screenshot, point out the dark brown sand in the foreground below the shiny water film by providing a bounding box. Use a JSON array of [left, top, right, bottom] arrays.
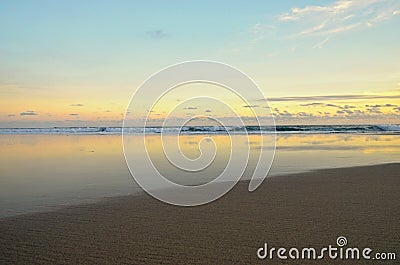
[[0, 163, 400, 264]]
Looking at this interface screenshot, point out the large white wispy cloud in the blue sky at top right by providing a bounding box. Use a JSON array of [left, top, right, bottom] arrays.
[[247, 0, 400, 51]]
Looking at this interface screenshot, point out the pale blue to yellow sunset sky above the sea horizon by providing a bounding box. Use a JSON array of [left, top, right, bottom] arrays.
[[0, 0, 400, 127]]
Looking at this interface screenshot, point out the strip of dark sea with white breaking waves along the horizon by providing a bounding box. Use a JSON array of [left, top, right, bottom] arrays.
[[0, 124, 400, 134]]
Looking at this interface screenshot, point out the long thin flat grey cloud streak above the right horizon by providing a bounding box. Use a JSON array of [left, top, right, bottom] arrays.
[[266, 94, 400, 102]]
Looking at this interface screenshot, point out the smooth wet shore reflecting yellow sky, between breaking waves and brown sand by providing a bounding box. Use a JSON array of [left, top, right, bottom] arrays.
[[0, 134, 400, 216]]
